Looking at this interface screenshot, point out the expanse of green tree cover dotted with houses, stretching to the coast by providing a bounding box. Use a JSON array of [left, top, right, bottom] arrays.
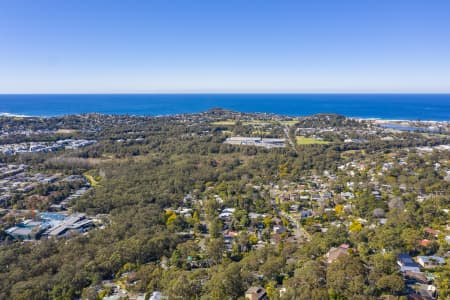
[[0, 110, 450, 300]]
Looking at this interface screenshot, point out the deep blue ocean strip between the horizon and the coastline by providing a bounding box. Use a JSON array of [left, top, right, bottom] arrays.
[[0, 94, 450, 121]]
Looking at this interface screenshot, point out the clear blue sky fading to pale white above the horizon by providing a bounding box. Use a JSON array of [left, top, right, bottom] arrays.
[[0, 0, 450, 93]]
